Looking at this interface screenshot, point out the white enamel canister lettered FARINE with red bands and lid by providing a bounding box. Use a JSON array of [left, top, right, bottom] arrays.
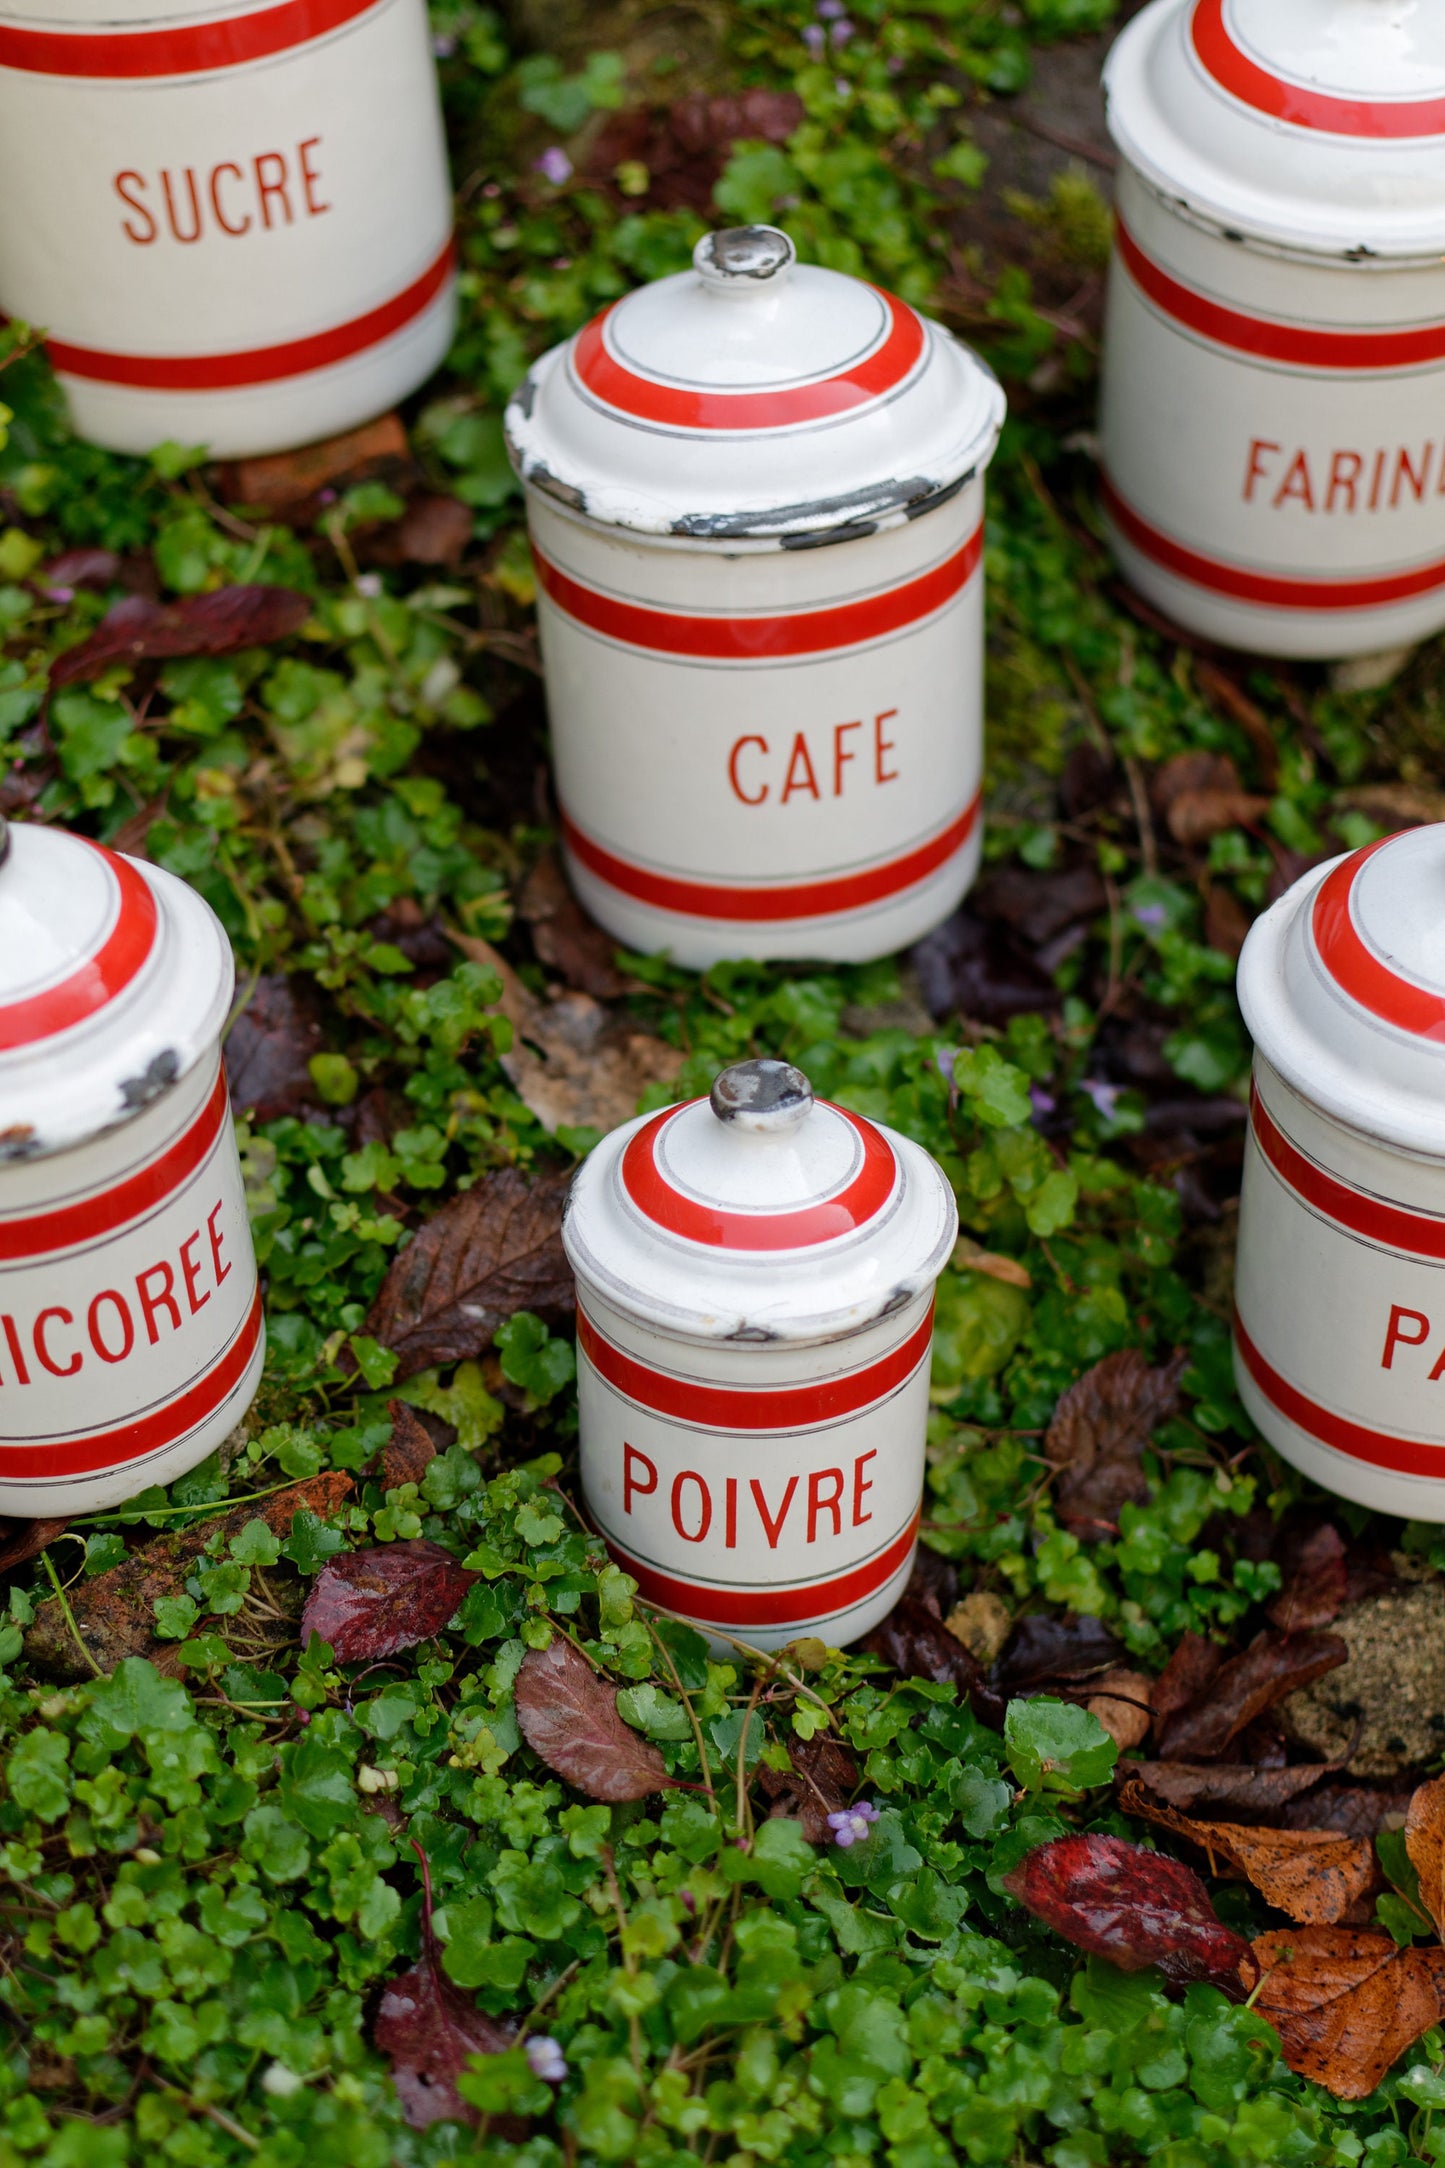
[[1101, 0, 1445, 657]]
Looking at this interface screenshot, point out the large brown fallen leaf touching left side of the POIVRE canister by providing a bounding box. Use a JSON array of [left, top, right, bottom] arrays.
[[366, 1166, 574, 1379]]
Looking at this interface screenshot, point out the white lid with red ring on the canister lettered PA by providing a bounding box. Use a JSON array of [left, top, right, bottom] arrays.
[[1239, 824, 1445, 1156]]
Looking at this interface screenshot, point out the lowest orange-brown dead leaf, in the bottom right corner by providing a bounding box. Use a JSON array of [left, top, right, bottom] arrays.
[[1252, 1927, 1445, 2101]]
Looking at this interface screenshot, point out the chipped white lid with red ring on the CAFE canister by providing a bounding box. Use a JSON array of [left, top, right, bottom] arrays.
[[507, 225, 1003, 542]]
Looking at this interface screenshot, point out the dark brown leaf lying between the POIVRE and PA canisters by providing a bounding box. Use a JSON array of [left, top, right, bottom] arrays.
[[1044, 1348, 1189, 1541]]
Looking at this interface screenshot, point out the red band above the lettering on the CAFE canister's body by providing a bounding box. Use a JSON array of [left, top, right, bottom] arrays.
[[533, 525, 984, 663]]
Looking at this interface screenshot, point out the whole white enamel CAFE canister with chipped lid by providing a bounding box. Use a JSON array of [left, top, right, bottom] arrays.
[[507, 225, 1003, 967]]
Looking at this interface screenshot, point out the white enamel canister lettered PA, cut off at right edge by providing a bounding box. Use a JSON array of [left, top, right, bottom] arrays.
[[1235, 826, 1445, 1520]]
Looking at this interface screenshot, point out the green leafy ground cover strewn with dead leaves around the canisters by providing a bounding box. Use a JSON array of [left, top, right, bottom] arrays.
[[0, 0, 1445, 2168]]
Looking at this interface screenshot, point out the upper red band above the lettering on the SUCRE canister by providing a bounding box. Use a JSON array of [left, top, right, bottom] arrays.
[[0, 0, 377, 82]]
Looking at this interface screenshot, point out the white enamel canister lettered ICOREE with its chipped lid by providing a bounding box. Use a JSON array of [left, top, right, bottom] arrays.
[[0, 822, 264, 1515]]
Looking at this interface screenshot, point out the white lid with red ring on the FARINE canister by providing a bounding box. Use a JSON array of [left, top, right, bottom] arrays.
[[1105, 0, 1445, 258]]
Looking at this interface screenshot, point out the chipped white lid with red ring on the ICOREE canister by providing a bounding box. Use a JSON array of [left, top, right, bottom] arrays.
[[0, 820, 234, 1160]]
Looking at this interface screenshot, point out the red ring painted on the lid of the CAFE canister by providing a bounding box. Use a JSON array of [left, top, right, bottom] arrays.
[[572, 286, 925, 429]]
